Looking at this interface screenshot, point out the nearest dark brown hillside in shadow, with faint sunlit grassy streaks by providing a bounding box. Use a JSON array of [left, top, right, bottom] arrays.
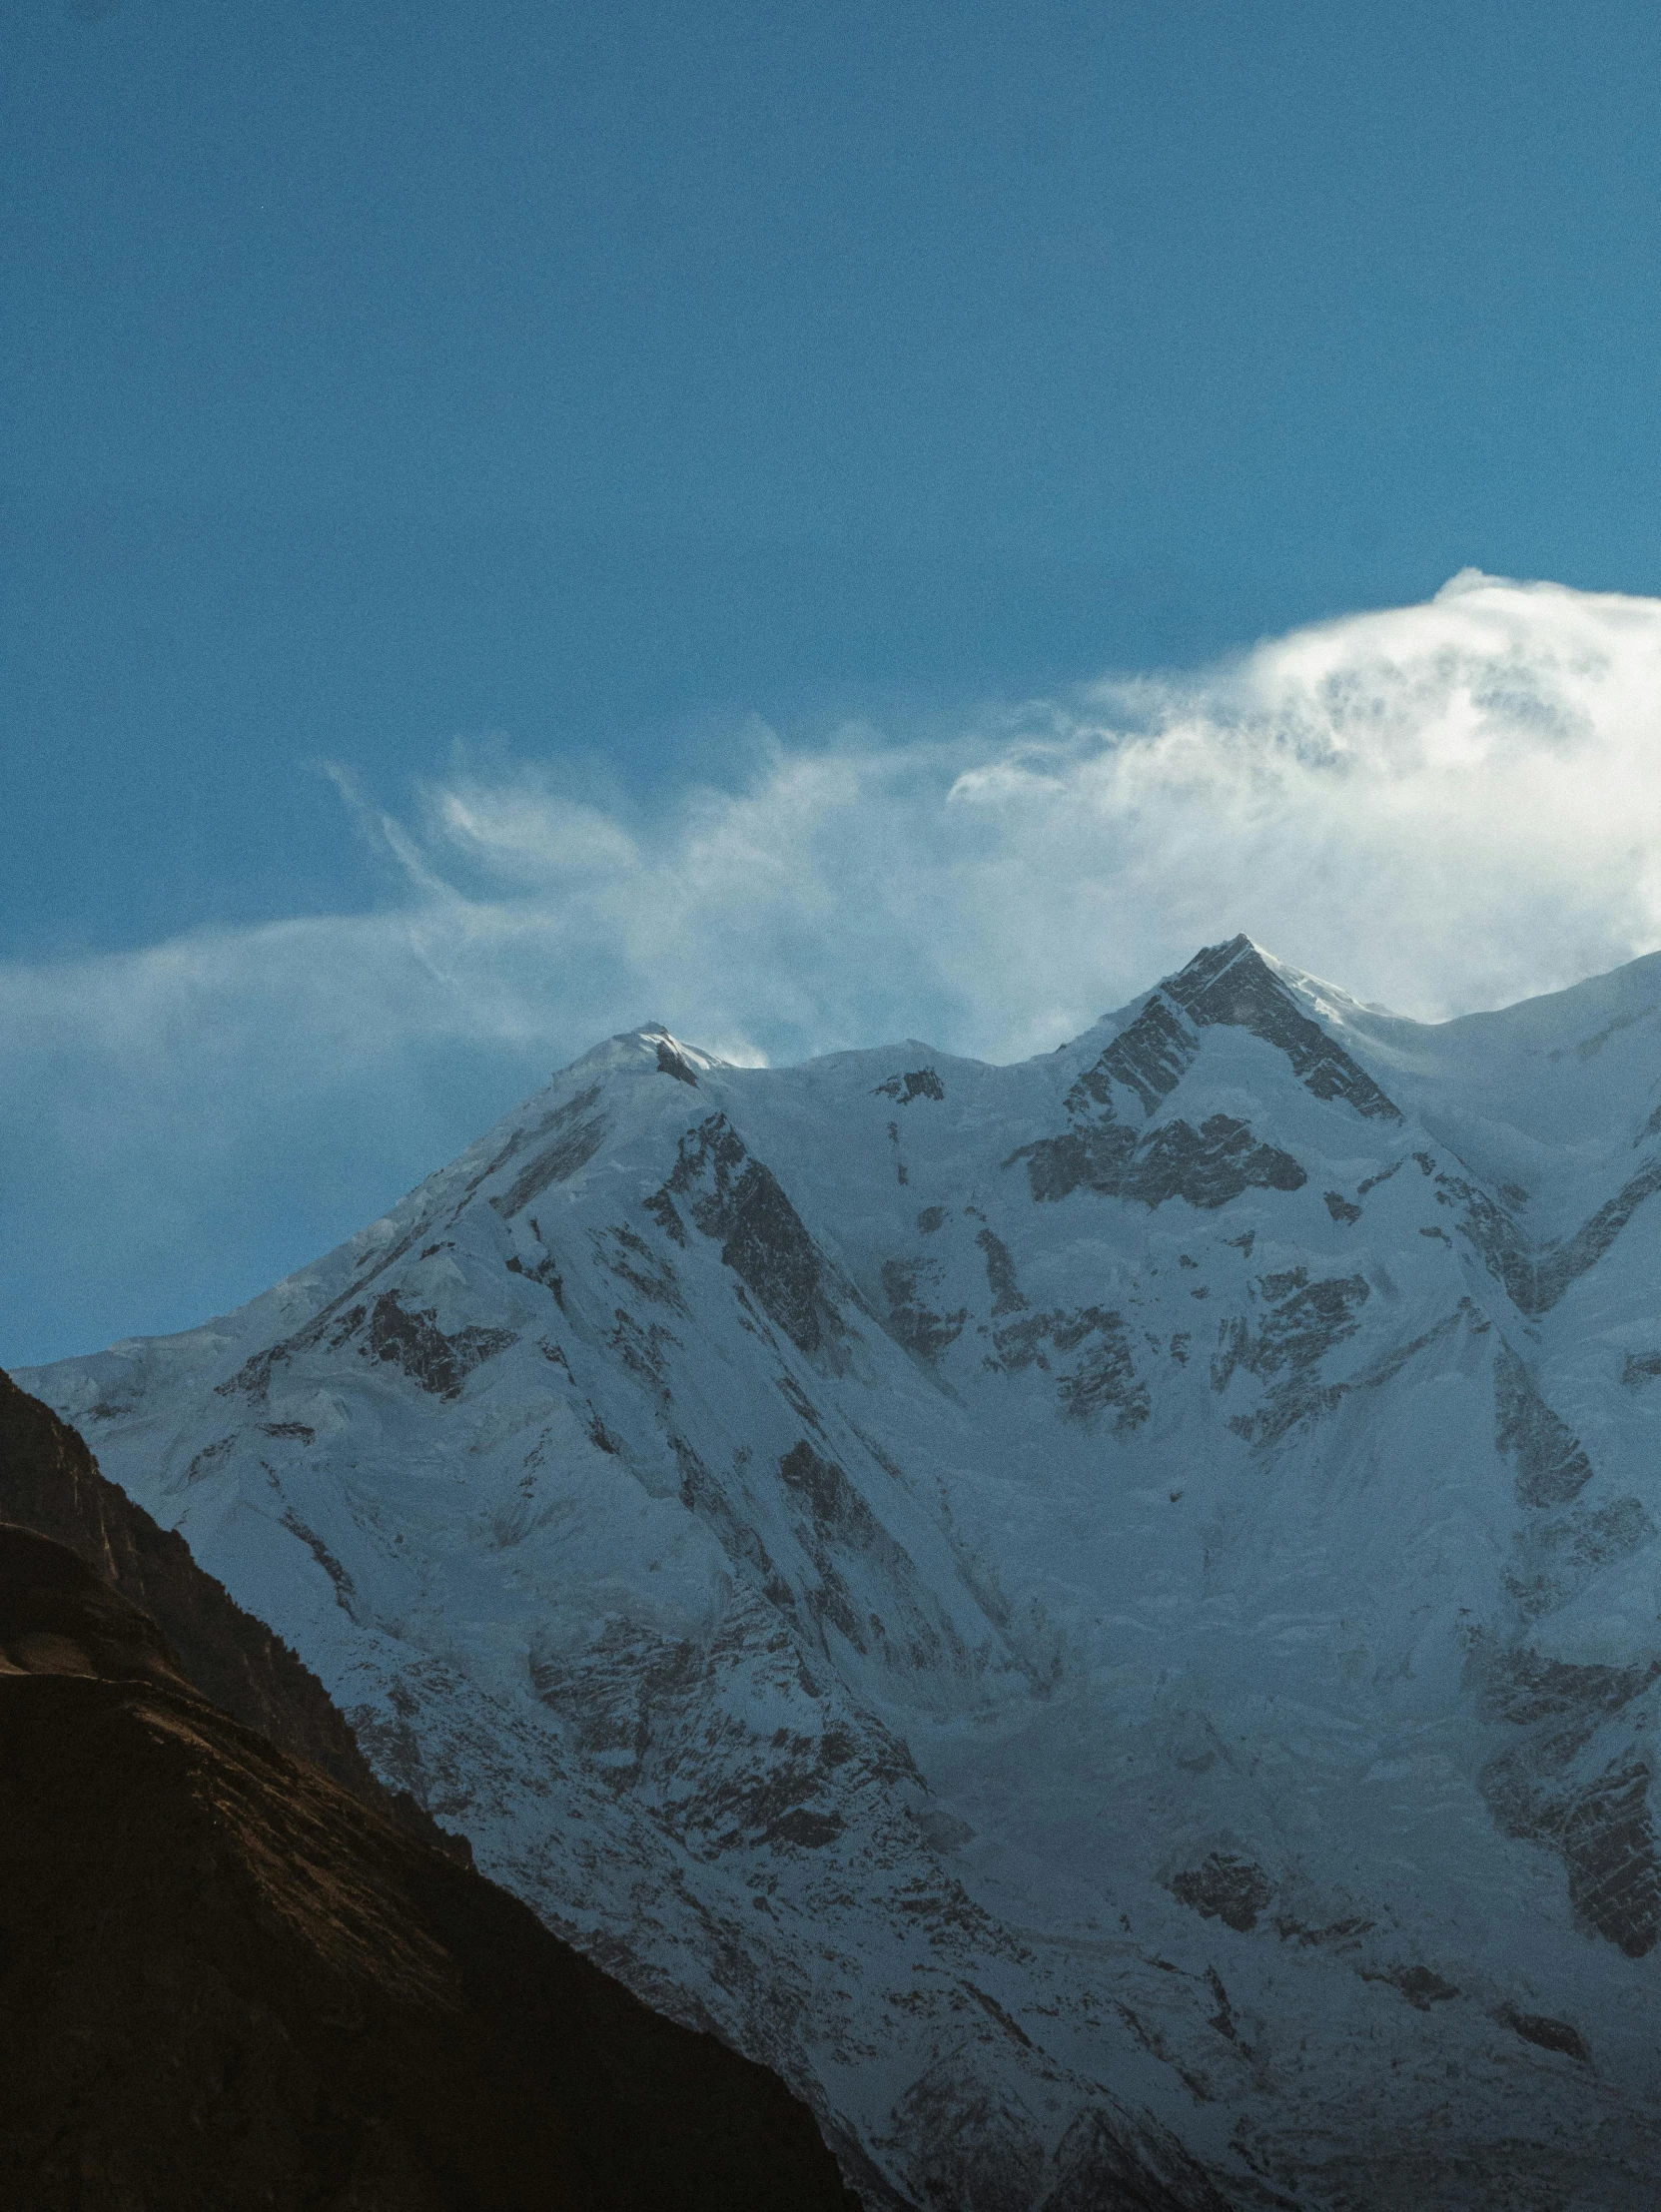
[[0, 1362, 856, 2212]]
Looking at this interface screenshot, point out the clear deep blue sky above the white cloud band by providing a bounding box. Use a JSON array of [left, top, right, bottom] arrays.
[[13, 0, 1661, 956]]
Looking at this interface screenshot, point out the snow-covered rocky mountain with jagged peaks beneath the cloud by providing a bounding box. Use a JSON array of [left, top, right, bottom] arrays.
[[22, 938, 1661, 2212]]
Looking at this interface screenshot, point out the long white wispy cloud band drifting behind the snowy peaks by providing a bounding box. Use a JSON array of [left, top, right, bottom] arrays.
[[0, 573, 1661, 1356]]
